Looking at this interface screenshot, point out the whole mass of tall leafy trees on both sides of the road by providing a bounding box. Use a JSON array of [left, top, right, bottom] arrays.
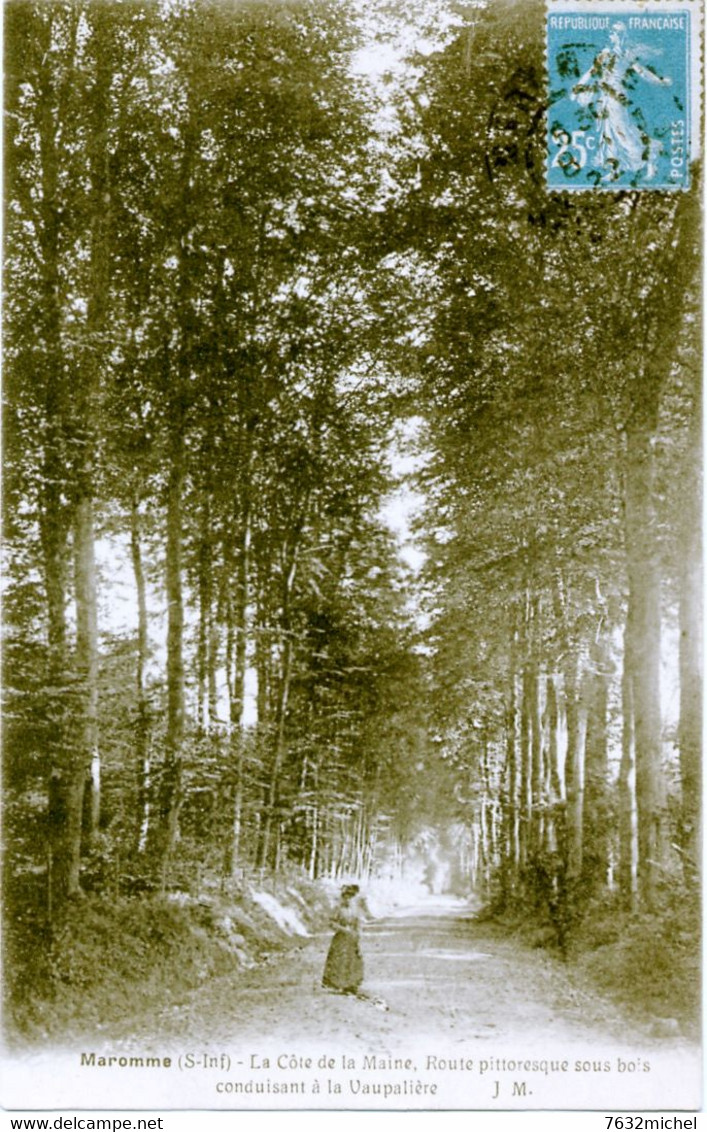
[[5, 0, 701, 1036]]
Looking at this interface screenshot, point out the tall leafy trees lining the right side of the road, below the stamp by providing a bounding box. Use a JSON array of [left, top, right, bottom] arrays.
[[398, 3, 701, 932]]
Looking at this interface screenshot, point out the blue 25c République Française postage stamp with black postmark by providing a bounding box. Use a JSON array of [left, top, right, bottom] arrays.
[[546, 0, 698, 190]]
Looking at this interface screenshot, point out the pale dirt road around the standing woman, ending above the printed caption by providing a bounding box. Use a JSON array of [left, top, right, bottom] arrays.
[[129, 898, 681, 1055]]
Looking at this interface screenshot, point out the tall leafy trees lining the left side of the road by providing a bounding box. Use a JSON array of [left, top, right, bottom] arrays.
[[7, 2, 436, 906]]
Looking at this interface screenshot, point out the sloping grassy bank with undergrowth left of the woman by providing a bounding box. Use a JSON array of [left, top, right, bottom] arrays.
[[5, 876, 330, 1046]]
